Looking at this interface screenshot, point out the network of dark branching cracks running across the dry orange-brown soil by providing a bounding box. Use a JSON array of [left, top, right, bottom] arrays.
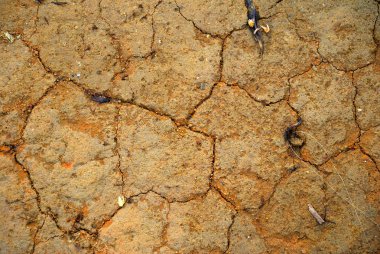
[[2, 0, 380, 253]]
